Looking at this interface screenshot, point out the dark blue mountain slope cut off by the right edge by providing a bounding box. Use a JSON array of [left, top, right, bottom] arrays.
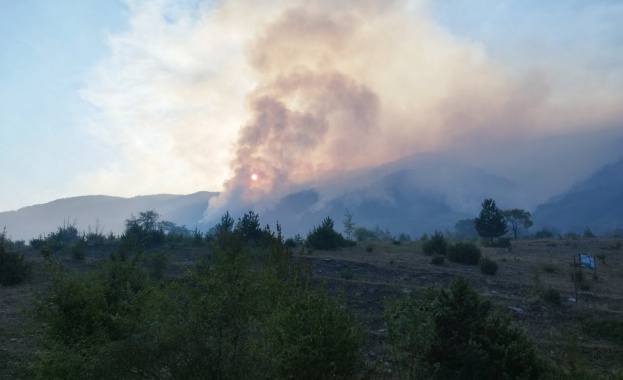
[[533, 160, 623, 234]]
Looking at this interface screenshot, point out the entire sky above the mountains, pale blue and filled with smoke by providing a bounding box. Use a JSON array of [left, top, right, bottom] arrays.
[[0, 0, 623, 215]]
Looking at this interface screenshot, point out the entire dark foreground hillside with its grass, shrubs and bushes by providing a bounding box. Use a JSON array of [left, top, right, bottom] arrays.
[[0, 206, 623, 379]]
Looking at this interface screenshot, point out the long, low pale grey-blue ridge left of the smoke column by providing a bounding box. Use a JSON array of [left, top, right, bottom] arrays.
[[0, 191, 217, 241]]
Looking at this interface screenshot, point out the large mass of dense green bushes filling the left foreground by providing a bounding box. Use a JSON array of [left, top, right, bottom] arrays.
[[34, 218, 362, 379]]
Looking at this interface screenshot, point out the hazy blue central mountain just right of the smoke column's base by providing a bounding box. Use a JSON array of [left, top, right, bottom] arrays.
[[261, 153, 523, 237]]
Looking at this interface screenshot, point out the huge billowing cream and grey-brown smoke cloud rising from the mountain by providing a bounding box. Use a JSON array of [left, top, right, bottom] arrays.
[[84, 0, 623, 220]]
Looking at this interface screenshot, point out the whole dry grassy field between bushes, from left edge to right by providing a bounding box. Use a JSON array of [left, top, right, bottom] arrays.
[[0, 238, 623, 379]]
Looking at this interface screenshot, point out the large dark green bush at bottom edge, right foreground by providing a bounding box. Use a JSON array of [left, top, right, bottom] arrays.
[[385, 277, 544, 379]]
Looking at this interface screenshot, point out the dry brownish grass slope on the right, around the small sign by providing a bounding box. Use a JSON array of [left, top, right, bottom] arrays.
[[307, 239, 623, 375]]
